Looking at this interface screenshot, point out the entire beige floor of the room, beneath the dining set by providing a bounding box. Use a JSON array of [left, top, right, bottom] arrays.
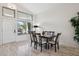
[[0, 41, 79, 56]]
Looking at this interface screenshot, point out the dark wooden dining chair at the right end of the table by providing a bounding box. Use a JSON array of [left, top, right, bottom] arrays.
[[49, 33, 61, 52]]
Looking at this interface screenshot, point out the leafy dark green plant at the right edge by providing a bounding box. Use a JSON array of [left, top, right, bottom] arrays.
[[70, 12, 79, 43]]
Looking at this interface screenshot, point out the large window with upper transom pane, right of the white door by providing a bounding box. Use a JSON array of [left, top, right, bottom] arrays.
[[17, 11, 32, 35]]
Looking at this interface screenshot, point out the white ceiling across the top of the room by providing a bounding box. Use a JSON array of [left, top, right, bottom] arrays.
[[16, 3, 79, 14]]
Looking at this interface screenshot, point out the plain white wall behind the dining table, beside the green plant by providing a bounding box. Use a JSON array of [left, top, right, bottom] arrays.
[[34, 4, 79, 46]]
